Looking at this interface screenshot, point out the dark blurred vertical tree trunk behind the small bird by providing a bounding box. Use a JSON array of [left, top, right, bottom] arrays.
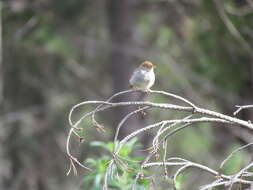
[[107, 0, 146, 141]]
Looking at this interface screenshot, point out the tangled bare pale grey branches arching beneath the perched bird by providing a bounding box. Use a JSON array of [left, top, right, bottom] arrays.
[[66, 90, 253, 190]]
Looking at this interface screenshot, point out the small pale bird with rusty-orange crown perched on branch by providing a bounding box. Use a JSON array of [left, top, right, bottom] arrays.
[[129, 61, 156, 92]]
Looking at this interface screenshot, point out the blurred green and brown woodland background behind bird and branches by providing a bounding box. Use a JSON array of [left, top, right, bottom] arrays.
[[0, 0, 253, 190]]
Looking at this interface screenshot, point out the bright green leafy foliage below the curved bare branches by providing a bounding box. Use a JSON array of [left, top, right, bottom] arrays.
[[82, 138, 150, 190]]
